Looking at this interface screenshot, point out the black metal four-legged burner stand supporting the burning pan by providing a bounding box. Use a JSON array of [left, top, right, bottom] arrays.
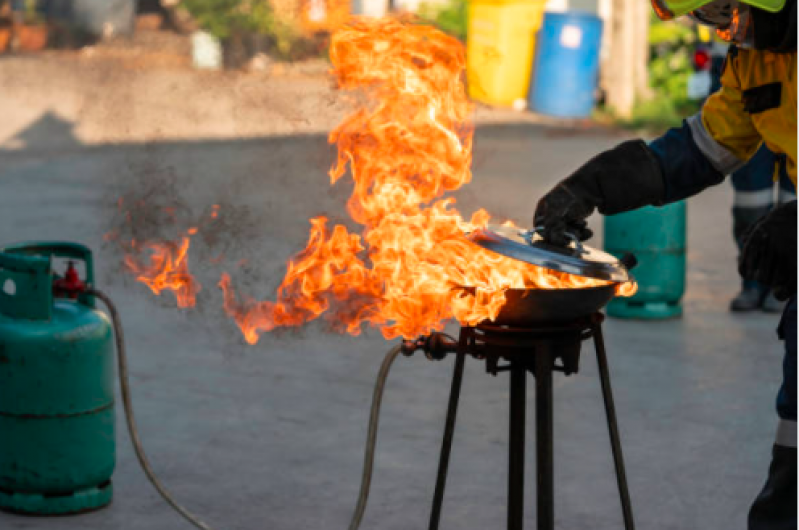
[[429, 313, 635, 530]]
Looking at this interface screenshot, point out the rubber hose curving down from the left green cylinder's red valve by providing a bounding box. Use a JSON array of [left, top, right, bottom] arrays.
[[86, 289, 213, 530]]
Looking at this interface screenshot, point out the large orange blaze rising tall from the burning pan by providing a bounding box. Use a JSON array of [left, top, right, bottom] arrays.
[[219, 19, 635, 344]]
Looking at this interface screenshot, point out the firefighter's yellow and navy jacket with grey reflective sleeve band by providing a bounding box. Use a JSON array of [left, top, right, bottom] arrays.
[[649, 46, 797, 203]]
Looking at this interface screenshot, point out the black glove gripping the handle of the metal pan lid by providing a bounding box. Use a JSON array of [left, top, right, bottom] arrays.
[[533, 140, 665, 246]]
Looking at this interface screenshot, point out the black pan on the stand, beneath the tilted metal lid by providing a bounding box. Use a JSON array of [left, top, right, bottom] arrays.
[[467, 283, 616, 328]]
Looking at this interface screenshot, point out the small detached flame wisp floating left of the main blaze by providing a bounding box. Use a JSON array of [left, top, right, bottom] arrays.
[[125, 234, 201, 307]]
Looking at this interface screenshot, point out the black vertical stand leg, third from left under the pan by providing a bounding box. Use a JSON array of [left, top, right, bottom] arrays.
[[535, 348, 555, 530]]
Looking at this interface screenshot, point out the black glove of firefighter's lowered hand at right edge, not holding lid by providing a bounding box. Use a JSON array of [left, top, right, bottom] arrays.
[[738, 201, 796, 300]]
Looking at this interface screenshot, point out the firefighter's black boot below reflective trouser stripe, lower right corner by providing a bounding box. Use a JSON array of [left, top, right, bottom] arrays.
[[749, 445, 796, 530]]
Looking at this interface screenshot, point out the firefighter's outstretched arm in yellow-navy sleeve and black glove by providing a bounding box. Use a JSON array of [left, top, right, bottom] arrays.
[[533, 48, 761, 244]]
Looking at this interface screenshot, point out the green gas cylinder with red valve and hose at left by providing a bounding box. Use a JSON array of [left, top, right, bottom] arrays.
[[0, 242, 115, 514]]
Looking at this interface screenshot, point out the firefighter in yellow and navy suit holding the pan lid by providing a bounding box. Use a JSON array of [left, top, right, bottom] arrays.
[[534, 0, 797, 530]]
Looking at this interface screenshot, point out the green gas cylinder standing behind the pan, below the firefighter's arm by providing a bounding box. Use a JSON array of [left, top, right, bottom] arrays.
[[605, 201, 685, 319]]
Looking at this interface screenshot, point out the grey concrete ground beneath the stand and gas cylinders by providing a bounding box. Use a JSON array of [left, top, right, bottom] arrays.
[[0, 57, 781, 530]]
